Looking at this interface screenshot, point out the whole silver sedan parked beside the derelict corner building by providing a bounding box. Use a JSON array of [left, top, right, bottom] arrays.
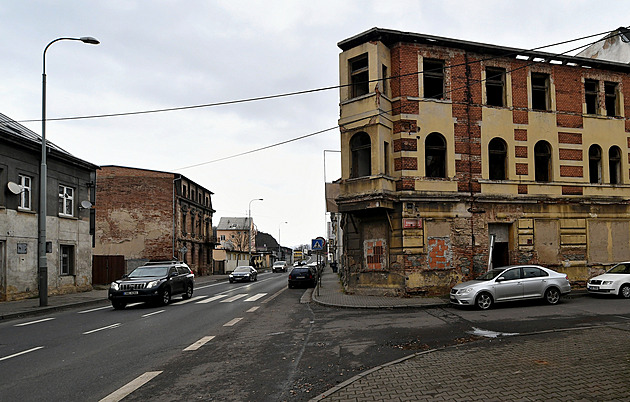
[[450, 265, 571, 310]]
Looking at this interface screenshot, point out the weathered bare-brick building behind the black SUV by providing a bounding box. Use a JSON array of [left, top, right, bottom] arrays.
[[94, 166, 215, 281]]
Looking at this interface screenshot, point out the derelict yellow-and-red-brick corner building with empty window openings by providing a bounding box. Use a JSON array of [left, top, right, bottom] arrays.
[[336, 28, 630, 294]]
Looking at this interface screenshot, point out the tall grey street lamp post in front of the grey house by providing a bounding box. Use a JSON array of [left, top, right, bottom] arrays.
[[37, 36, 100, 307]]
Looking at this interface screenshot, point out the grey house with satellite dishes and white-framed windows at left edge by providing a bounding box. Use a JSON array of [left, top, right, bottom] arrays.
[[0, 114, 98, 301]]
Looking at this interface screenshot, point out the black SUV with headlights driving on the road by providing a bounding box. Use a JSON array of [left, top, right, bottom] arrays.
[[108, 261, 195, 310]]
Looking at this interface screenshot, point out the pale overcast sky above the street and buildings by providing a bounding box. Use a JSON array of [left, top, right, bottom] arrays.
[[0, 0, 630, 246]]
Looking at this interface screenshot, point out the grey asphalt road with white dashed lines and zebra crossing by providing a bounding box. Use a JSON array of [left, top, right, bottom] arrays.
[[0, 273, 630, 401]]
